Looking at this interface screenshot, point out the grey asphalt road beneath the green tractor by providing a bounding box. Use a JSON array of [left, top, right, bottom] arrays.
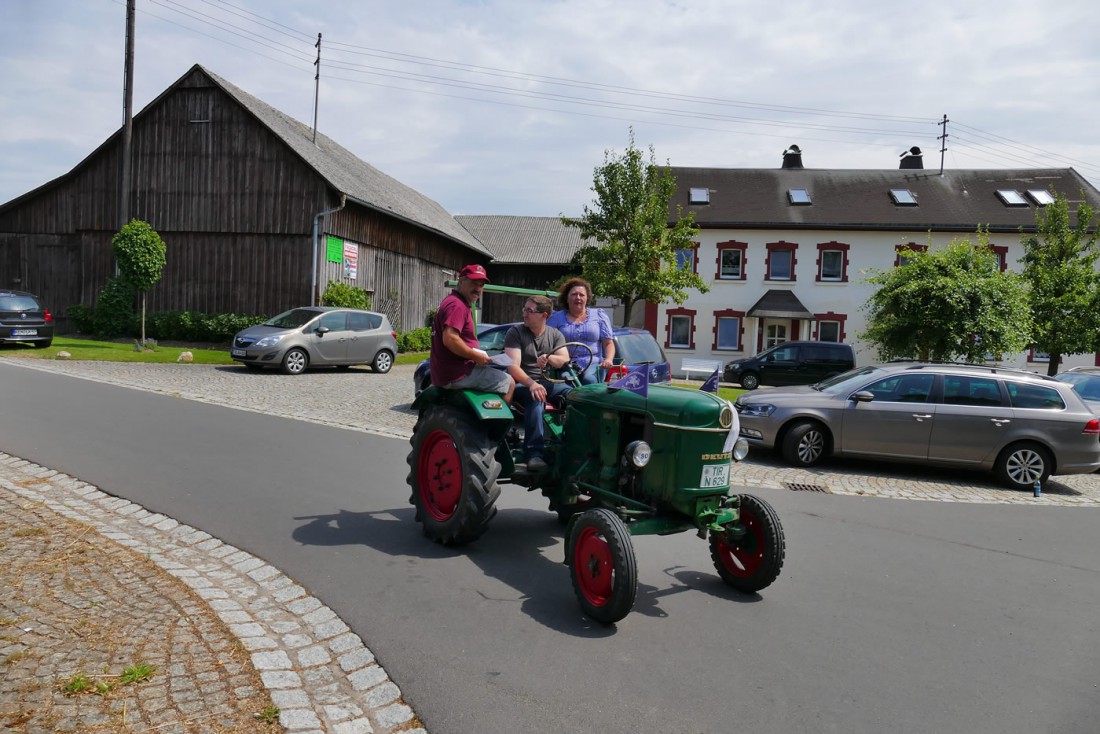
[[0, 363, 1100, 734]]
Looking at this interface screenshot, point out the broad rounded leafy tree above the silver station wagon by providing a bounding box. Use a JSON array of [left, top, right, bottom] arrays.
[[860, 236, 1031, 362]]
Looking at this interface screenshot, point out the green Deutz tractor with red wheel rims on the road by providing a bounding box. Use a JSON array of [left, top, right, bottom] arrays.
[[408, 342, 787, 624]]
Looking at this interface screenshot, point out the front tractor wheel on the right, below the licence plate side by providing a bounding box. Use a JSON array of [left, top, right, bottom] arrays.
[[711, 494, 787, 593]]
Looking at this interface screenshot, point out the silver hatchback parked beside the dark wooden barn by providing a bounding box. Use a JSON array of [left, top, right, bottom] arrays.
[[229, 306, 397, 374]]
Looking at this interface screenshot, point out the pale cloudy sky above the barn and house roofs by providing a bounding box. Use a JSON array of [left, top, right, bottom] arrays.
[[0, 0, 1100, 216]]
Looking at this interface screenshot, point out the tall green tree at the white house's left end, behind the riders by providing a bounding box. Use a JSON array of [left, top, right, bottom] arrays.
[[561, 129, 708, 324]]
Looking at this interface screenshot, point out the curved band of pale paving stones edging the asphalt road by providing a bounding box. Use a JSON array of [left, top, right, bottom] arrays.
[[0, 452, 427, 734]]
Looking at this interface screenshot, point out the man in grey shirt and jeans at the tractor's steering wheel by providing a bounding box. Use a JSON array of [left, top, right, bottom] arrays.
[[504, 296, 570, 471]]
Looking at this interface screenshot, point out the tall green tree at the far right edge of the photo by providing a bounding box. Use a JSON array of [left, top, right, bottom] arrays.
[[1020, 193, 1100, 374]]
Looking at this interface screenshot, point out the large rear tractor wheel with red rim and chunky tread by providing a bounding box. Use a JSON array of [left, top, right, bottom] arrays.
[[408, 406, 501, 546]]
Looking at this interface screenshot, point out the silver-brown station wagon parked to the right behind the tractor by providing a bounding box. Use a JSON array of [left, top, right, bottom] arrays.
[[736, 363, 1100, 489]]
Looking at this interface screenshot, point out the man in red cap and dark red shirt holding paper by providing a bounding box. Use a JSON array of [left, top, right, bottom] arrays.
[[430, 265, 516, 403]]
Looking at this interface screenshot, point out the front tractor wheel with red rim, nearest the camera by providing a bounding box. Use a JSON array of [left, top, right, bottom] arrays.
[[565, 507, 638, 624]]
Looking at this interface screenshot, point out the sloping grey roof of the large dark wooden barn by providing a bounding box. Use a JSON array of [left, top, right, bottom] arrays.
[[199, 64, 492, 255]]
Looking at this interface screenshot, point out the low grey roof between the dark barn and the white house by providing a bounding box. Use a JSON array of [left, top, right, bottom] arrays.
[[454, 215, 598, 265]]
